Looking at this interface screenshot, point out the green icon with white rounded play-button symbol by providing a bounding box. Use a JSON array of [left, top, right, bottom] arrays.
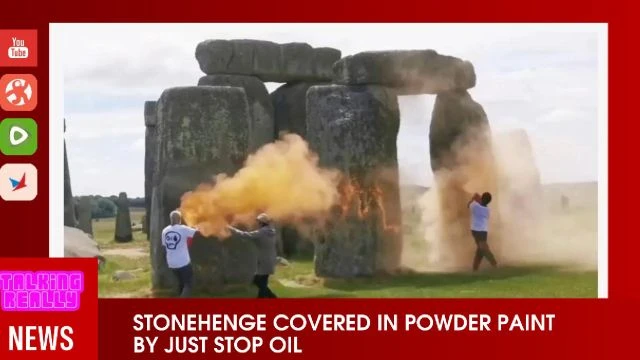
[[0, 118, 38, 156]]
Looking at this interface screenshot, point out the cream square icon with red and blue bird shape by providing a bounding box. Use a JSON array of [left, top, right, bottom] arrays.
[[0, 164, 38, 201]]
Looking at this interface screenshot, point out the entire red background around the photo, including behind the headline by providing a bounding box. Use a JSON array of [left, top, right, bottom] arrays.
[[0, 0, 640, 359]]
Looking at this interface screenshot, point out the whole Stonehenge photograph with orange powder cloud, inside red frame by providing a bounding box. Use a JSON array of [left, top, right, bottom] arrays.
[[56, 24, 607, 298]]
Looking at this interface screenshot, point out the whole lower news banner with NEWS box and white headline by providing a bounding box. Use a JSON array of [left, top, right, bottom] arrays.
[[0, 258, 640, 360]]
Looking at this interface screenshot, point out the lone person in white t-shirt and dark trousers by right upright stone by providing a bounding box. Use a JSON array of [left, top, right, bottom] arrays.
[[469, 192, 498, 271]]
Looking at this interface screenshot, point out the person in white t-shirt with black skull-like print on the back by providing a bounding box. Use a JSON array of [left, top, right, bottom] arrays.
[[162, 210, 197, 297]]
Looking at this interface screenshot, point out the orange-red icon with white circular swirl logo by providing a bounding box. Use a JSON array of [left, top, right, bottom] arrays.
[[0, 74, 38, 111]]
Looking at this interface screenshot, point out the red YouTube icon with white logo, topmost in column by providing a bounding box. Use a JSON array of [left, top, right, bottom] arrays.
[[0, 29, 38, 67]]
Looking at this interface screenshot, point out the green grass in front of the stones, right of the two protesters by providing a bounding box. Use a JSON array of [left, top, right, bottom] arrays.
[[219, 260, 598, 298]]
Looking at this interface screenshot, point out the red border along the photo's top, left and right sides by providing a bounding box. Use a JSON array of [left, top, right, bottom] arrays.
[[0, 0, 640, 297]]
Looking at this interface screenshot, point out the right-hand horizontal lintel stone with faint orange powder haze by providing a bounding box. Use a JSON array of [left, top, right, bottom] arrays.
[[333, 50, 476, 95]]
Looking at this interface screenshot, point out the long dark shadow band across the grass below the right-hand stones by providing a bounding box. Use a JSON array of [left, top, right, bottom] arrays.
[[324, 266, 557, 292]]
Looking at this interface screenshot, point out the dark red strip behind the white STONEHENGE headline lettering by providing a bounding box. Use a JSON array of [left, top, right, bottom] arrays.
[[99, 299, 624, 360]]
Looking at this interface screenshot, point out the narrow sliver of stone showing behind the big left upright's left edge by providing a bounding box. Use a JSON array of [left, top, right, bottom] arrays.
[[142, 101, 158, 240]]
